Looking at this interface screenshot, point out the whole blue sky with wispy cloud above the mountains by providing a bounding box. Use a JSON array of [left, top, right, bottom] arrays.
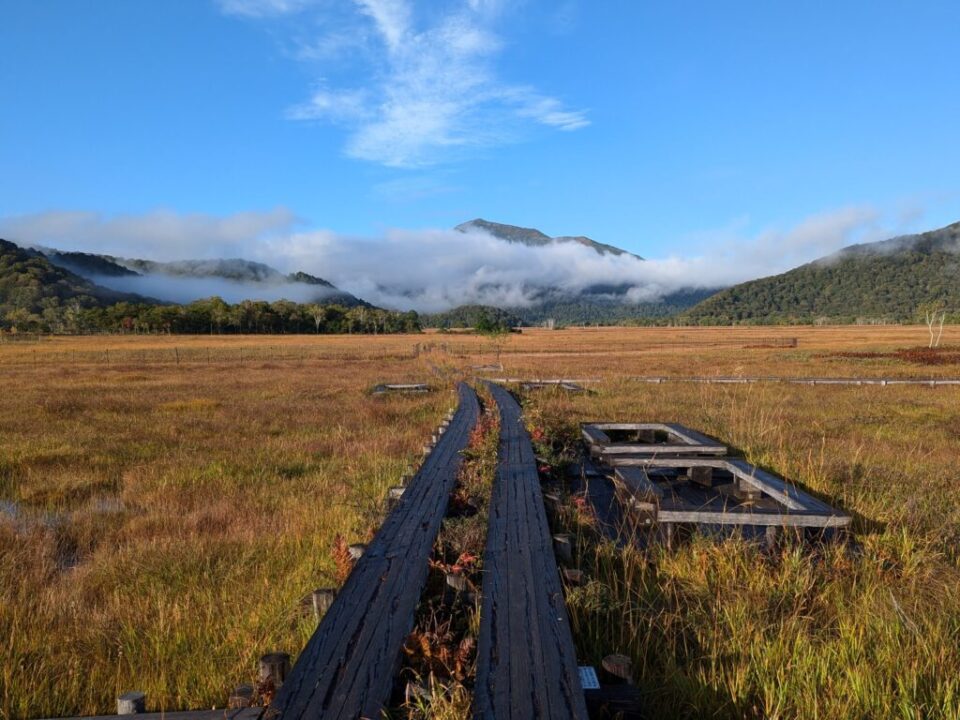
[[0, 0, 960, 306]]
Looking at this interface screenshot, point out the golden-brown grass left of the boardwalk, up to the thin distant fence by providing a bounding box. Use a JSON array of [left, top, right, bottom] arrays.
[[0, 344, 455, 719]]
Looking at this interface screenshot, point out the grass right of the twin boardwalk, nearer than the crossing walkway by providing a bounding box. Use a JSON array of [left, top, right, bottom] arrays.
[[527, 381, 960, 719]]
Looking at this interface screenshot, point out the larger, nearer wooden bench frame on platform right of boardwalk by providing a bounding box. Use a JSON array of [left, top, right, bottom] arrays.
[[602, 454, 850, 528]]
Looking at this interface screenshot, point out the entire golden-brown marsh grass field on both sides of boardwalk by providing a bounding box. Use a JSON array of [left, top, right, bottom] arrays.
[[0, 327, 960, 719]]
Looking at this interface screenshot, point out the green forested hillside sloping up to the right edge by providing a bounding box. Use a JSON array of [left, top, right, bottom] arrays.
[[684, 223, 960, 325]]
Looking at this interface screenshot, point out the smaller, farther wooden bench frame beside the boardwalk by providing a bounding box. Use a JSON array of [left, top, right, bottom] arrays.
[[580, 422, 727, 457]]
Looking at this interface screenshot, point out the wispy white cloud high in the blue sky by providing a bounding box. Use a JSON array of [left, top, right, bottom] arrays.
[[221, 0, 590, 168]]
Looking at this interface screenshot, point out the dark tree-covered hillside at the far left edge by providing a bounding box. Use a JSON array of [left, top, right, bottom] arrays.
[[0, 240, 145, 325]]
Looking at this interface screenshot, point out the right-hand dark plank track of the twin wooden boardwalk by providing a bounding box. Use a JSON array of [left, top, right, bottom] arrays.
[[474, 383, 587, 720]]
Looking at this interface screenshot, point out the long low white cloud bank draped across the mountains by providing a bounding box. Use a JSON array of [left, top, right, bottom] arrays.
[[0, 207, 892, 312]]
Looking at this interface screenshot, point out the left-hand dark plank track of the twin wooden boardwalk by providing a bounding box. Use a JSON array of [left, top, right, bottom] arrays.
[[264, 383, 480, 720]]
